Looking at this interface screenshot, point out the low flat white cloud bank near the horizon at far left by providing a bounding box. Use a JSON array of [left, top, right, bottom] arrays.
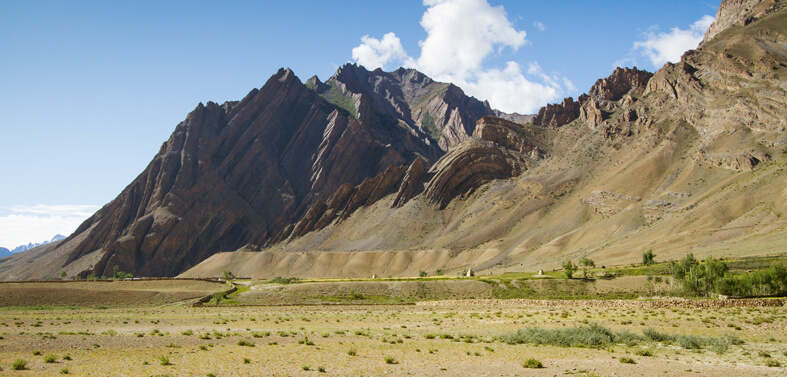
[[0, 204, 99, 249]]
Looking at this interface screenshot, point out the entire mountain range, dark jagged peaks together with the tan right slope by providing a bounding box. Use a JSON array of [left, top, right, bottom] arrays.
[[0, 0, 787, 280]]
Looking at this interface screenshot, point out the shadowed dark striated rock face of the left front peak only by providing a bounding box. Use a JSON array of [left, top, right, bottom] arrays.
[[61, 69, 440, 276]]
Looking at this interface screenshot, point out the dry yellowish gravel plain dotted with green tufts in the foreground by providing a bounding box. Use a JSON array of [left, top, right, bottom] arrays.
[[0, 285, 787, 376]]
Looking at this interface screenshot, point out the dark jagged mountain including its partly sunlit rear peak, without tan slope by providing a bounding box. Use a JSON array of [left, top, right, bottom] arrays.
[[0, 65, 504, 276]]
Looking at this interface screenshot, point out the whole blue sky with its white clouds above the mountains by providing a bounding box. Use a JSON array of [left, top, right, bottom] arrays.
[[0, 0, 719, 247]]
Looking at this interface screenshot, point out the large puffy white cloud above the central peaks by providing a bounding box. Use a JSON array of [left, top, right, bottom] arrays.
[[353, 0, 574, 114]]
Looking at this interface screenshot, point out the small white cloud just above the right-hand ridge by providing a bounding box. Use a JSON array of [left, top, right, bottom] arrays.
[[636, 15, 714, 67]]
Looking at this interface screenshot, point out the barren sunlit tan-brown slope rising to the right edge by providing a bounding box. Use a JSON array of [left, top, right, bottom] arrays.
[[191, 2, 787, 276]]
